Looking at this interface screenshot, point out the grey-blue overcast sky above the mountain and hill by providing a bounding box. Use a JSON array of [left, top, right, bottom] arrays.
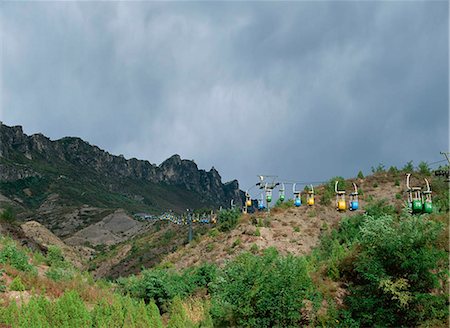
[[0, 1, 449, 189]]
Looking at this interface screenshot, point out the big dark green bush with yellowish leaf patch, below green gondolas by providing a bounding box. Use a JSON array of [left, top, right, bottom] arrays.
[[346, 215, 448, 326]]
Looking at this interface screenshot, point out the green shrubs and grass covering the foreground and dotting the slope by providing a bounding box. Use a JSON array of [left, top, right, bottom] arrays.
[[0, 170, 449, 328]]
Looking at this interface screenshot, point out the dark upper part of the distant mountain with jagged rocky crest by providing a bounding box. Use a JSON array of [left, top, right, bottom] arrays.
[[0, 123, 243, 207]]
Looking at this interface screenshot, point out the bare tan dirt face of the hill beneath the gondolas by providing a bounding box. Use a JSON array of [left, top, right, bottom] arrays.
[[164, 173, 406, 269]]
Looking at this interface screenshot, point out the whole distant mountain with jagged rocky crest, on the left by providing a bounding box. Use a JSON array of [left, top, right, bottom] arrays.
[[0, 123, 243, 237]]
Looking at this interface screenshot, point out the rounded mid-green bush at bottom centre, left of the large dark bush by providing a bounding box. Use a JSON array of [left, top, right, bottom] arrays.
[[211, 248, 313, 327]]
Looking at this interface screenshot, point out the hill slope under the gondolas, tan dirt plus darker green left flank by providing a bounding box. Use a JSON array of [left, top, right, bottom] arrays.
[[92, 172, 445, 278]]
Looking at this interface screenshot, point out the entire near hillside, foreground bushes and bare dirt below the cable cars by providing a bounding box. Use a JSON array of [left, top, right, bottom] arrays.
[[0, 168, 449, 328]]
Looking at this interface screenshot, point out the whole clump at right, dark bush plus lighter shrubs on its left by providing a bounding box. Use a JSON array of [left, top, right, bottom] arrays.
[[311, 201, 449, 327]]
